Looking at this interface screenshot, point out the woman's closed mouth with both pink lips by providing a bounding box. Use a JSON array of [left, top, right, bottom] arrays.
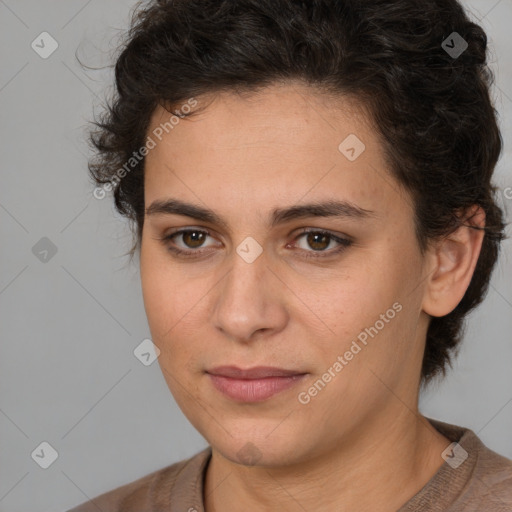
[[206, 366, 307, 403]]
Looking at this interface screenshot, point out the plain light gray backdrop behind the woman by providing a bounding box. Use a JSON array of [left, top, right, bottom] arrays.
[[0, 0, 512, 512]]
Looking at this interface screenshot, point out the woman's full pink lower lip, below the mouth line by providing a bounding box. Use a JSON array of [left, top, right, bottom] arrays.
[[208, 374, 305, 402]]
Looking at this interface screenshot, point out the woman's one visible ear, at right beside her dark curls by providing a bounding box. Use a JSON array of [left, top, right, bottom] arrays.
[[423, 205, 485, 317]]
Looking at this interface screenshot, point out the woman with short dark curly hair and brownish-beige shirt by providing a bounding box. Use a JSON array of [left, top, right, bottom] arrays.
[[69, 0, 512, 512]]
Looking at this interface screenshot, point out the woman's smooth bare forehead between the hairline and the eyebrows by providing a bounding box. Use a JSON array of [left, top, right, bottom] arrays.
[[145, 85, 407, 225]]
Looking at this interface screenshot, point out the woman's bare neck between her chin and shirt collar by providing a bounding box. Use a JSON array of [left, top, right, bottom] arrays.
[[204, 404, 450, 512]]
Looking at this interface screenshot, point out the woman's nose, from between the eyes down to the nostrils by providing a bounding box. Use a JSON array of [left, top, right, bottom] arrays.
[[213, 248, 288, 343]]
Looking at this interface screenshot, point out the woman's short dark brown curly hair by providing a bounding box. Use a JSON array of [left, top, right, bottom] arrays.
[[89, 0, 505, 383]]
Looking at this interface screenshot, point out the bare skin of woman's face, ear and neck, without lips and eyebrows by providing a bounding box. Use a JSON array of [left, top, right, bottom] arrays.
[[140, 82, 485, 512]]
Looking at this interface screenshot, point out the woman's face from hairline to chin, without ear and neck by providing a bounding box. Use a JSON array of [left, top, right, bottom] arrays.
[[141, 84, 427, 465]]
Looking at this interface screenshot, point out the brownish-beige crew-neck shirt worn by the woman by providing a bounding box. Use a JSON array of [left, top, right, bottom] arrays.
[[68, 418, 512, 512]]
